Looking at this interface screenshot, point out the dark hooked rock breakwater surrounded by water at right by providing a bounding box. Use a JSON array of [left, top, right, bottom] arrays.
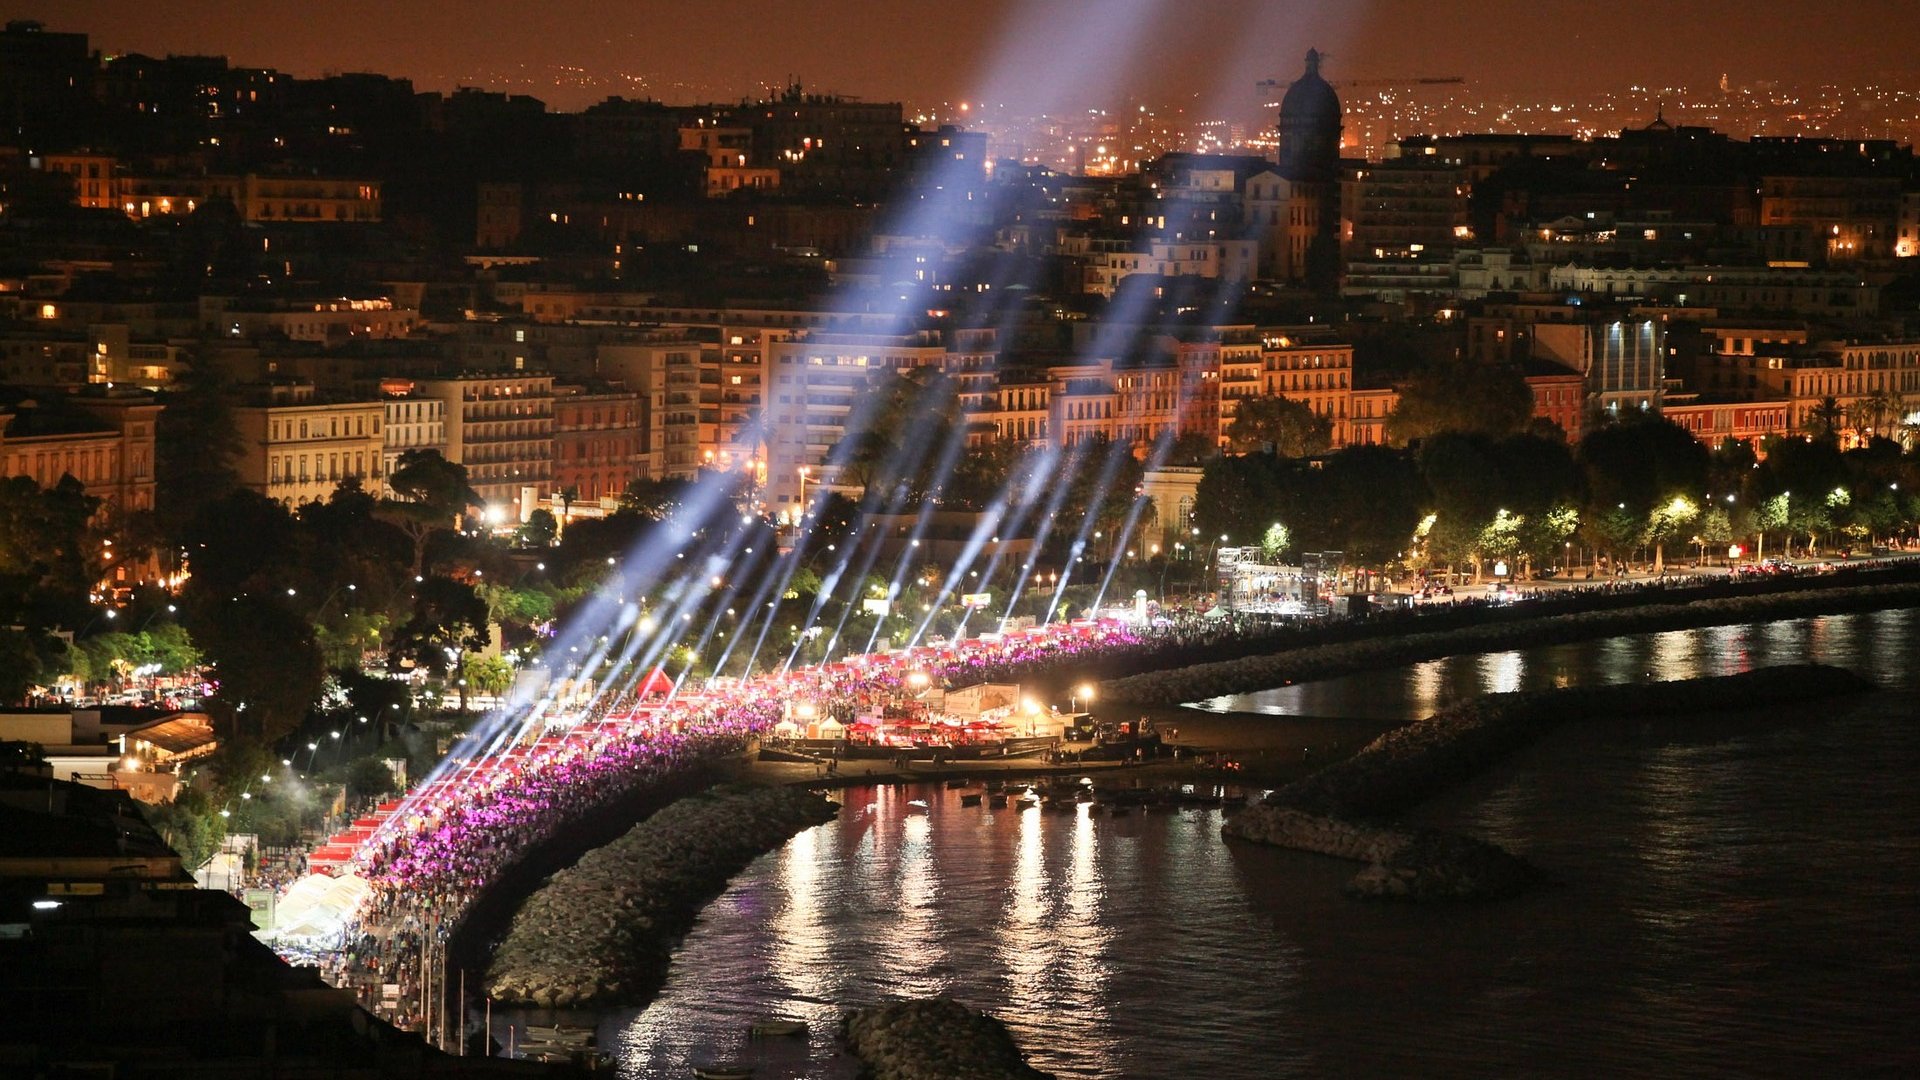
[[1221, 665, 1872, 899]]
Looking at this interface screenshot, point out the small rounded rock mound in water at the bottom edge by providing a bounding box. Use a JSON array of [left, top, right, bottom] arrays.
[[841, 997, 1050, 1080]]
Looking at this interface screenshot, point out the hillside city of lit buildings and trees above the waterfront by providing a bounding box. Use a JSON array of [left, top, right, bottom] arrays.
[[0, 21, 1920, 1070]]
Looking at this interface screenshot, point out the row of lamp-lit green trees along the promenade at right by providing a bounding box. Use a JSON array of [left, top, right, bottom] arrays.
[[1194, 415, 1920, 569]]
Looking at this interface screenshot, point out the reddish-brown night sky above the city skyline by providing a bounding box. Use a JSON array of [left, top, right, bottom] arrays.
[[0, 0, 1920, 111]]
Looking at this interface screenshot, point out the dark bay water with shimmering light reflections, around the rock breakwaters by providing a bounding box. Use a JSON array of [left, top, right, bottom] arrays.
[[568, 611, 1920, 1080]]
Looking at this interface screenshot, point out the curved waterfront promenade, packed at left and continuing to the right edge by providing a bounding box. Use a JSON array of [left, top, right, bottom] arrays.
[[266, 545, 1912, 1043]]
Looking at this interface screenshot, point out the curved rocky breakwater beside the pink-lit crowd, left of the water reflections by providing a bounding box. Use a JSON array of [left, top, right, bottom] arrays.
[[486, 784, 839, 1007]]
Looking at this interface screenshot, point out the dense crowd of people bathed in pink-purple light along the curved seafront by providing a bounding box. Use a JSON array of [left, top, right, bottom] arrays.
[[280, 625, 1140, 1026]]
